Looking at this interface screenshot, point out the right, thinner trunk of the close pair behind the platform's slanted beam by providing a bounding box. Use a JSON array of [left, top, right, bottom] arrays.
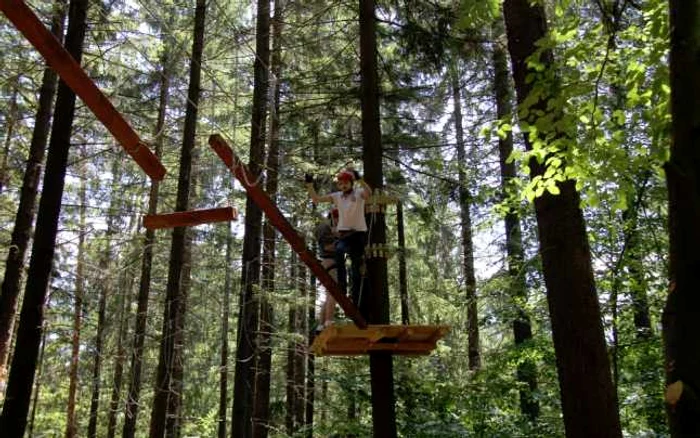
[[252, 0, 284, 438]]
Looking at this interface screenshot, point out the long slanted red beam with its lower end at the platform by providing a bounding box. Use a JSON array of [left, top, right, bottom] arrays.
[[209, 134, 367, 329]]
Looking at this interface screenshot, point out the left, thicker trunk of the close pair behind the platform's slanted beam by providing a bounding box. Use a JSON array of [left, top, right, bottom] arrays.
[[231, 1, 270, 438]]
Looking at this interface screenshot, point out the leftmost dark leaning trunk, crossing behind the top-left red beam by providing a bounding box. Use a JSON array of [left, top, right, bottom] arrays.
[[0, 0, 66, 376]]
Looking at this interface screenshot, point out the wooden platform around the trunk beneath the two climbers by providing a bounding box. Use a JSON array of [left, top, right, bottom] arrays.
[[311, 324, 450, 356]]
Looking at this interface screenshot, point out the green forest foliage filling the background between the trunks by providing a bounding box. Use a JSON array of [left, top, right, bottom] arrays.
[[0, 0, 670, 438]]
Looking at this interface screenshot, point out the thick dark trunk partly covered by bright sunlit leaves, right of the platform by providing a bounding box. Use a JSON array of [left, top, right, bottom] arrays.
[[504, 0, 621, 437]]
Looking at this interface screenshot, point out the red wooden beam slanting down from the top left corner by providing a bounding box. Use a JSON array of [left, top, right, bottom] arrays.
[[0, 0, 165, 180]]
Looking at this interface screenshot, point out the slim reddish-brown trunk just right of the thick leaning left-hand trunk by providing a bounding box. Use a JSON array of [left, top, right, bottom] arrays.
[[65, 155, 87, 438]]
